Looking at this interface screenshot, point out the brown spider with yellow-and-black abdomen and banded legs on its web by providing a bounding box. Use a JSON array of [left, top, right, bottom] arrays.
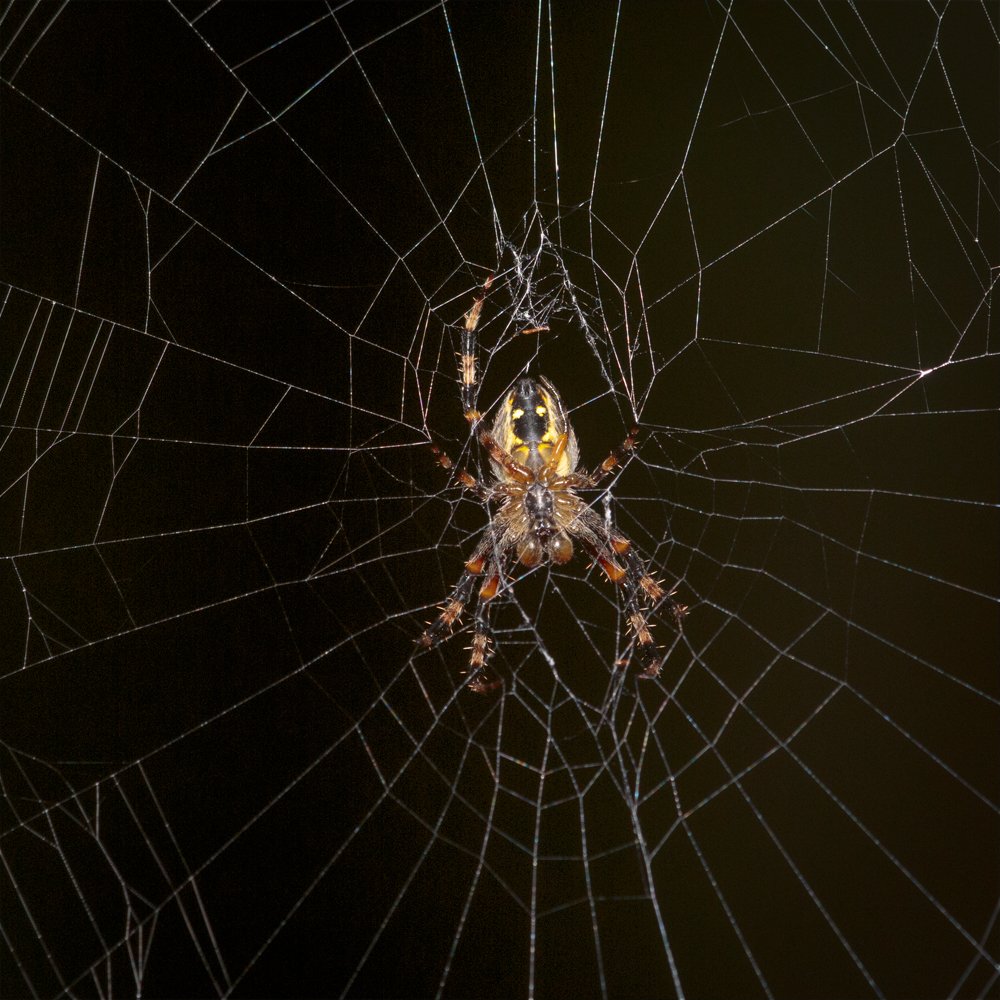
[[417, 275, 687, 693]]
